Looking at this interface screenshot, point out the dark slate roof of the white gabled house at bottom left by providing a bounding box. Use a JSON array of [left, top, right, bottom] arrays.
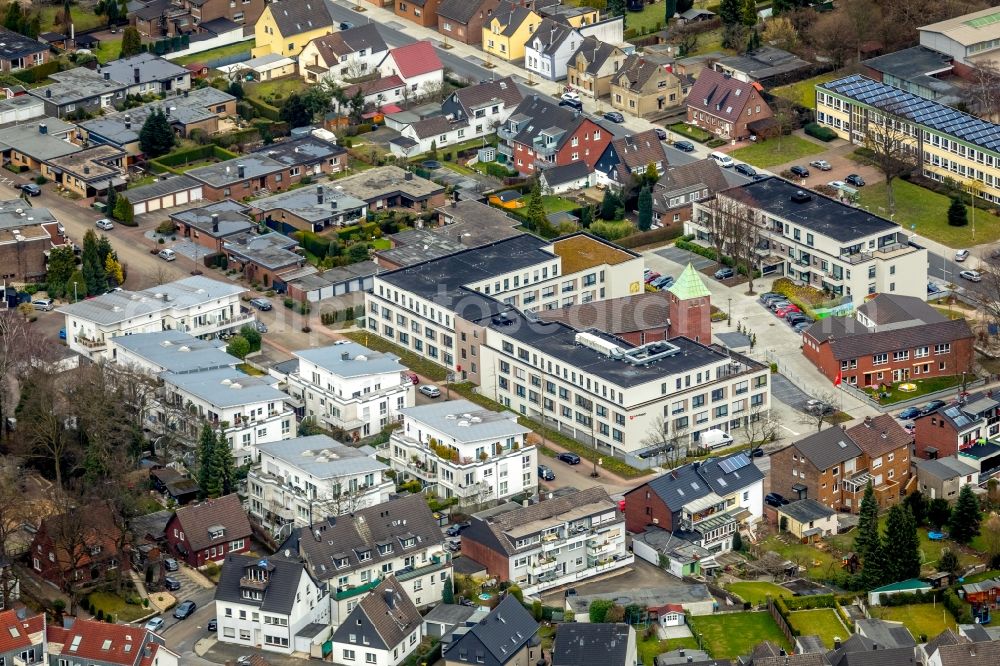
[[215, 555, 312, 615]]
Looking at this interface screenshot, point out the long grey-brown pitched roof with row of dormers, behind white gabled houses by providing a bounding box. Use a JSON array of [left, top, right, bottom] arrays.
[[279, 495, 444, 580]]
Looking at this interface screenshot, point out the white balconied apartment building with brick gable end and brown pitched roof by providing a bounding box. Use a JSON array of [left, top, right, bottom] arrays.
[[462, 487, 635, 595]]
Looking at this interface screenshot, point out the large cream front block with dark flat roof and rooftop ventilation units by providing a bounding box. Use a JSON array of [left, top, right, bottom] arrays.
[[479, 312, 771, 453]]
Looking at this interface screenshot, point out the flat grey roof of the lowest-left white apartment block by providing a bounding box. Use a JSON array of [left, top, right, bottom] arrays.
[[257, 435, 388, 479]]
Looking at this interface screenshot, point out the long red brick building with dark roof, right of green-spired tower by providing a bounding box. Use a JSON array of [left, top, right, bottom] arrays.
[[802, 294, 973, 386]]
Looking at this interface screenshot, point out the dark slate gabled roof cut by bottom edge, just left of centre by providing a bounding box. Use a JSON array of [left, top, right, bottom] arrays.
[[442, 595, 538, 666]]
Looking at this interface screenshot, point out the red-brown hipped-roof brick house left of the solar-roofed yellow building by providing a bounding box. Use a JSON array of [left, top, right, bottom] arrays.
[[687, 67, 774, 140]]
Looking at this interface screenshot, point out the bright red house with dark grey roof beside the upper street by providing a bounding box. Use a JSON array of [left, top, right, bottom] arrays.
[[497, 95, 613, 175]]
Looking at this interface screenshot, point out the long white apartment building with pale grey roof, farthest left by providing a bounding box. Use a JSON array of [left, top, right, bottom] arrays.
[[56, 275, 256, 361]]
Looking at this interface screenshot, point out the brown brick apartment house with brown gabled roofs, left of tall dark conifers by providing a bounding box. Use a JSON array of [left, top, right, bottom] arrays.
[[771, 414, 912, 513]]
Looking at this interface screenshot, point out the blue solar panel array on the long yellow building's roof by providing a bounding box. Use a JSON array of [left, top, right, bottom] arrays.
[[820, 74, 1000, 152]]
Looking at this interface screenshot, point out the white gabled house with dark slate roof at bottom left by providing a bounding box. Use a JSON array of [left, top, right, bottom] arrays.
[[215, 555, 330, 654]]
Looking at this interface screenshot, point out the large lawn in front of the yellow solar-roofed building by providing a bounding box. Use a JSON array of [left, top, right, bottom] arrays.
[[858, 178, 1000, 248]]
